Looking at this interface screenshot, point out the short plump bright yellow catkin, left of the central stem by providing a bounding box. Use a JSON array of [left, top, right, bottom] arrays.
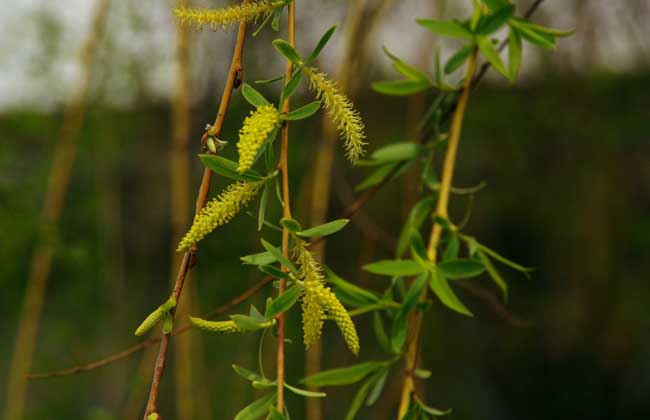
[[237, 105, 280, 173]]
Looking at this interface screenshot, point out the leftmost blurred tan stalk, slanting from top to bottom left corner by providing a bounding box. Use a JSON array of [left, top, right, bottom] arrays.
[[3, 0, 111, 420]]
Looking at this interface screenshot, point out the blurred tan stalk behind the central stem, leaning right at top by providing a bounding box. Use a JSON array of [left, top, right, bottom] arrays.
[[305, 0, 392, 420]]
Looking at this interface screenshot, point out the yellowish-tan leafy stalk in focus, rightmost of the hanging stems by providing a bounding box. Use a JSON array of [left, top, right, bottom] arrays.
[[397, 50, 477, 419]]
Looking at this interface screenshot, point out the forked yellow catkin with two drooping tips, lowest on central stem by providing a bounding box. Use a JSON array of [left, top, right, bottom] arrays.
[[294, 240, 359, 355]]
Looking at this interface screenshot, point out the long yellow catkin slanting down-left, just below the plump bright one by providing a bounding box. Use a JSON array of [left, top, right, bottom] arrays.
[[177, 182, 263, 251]]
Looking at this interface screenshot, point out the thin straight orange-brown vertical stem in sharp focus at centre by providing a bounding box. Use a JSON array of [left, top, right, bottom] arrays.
[[276, 0, 296, 413]]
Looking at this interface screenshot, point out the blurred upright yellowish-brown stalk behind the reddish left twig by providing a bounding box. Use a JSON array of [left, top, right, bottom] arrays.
[[169, 1, 210, 419]]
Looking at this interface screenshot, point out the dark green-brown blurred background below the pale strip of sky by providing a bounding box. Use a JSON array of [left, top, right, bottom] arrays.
[[0, 2, 650, 420]]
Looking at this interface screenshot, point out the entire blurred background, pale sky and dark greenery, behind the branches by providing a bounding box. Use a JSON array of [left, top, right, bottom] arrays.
[[0, 0, 650, 420]]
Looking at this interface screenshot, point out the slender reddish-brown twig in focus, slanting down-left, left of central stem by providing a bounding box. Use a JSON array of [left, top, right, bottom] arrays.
[[144, 0, 248, 420]]
